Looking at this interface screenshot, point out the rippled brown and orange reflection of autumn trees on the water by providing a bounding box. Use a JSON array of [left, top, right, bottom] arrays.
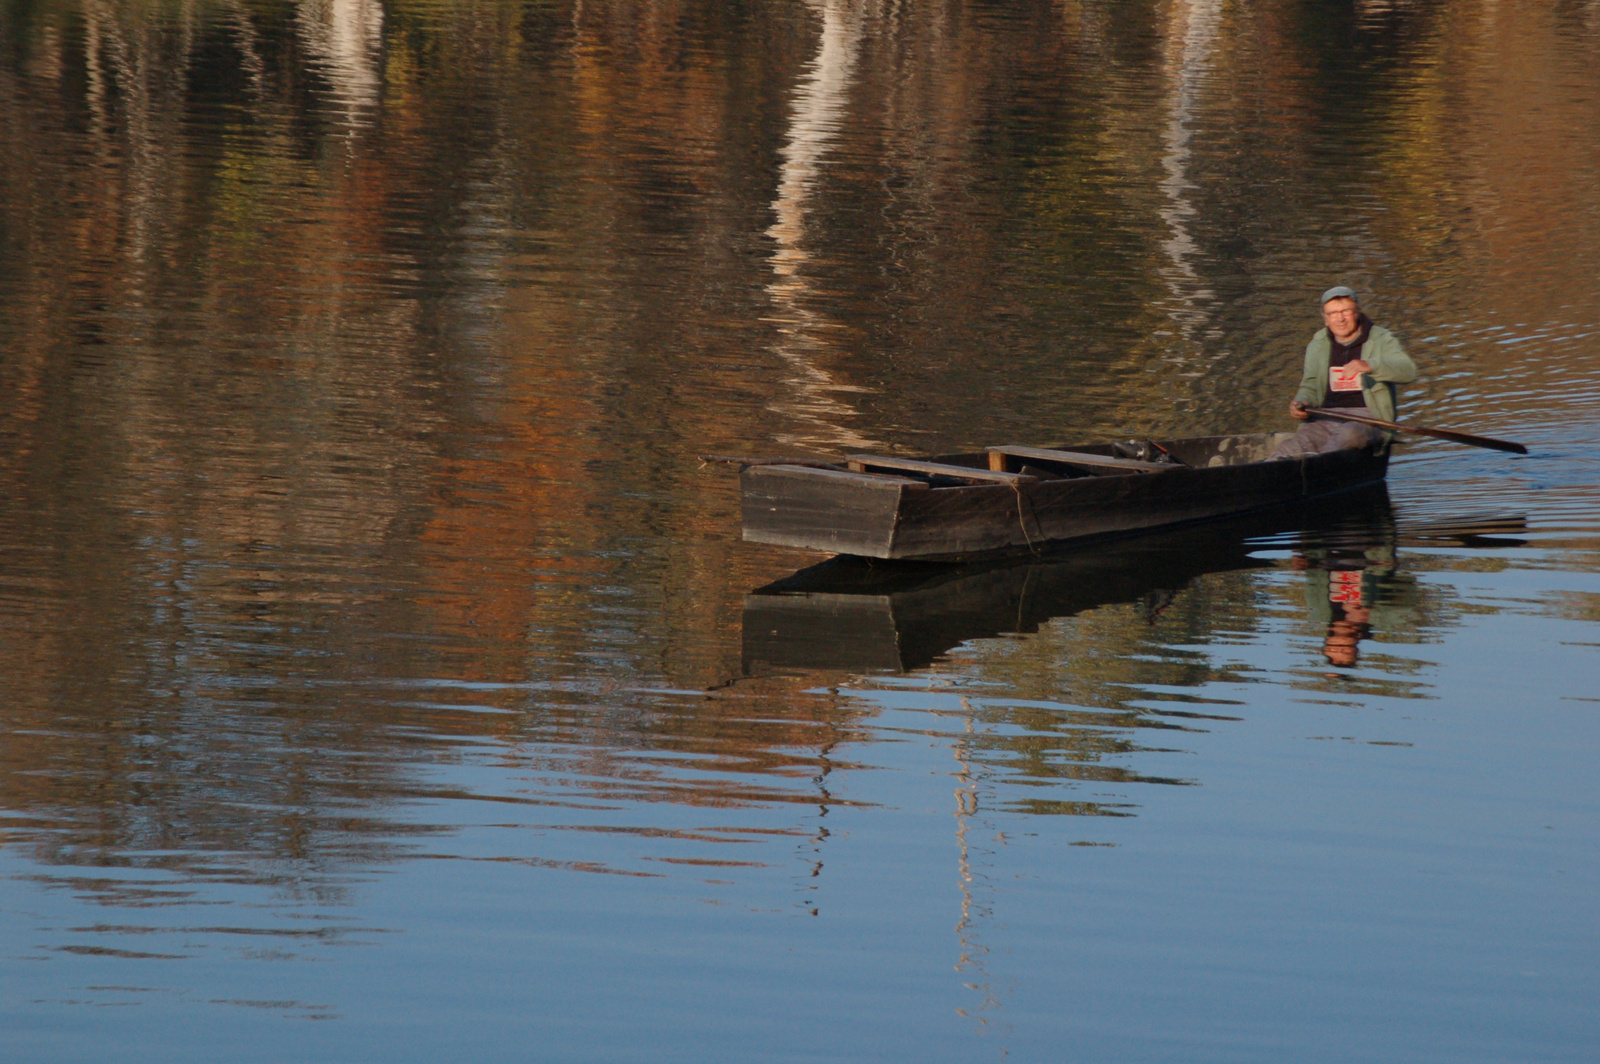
[[0, 0, 1600, 861]]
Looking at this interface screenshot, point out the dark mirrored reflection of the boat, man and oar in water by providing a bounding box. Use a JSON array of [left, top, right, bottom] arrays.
[[742, 485, 1525, 675]]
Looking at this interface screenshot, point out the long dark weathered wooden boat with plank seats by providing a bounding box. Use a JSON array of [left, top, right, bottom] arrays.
[[739, 434, 1389, 560]]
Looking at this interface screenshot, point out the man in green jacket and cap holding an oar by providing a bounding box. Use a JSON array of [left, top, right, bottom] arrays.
[[1269, 285, 1416, 458]]
